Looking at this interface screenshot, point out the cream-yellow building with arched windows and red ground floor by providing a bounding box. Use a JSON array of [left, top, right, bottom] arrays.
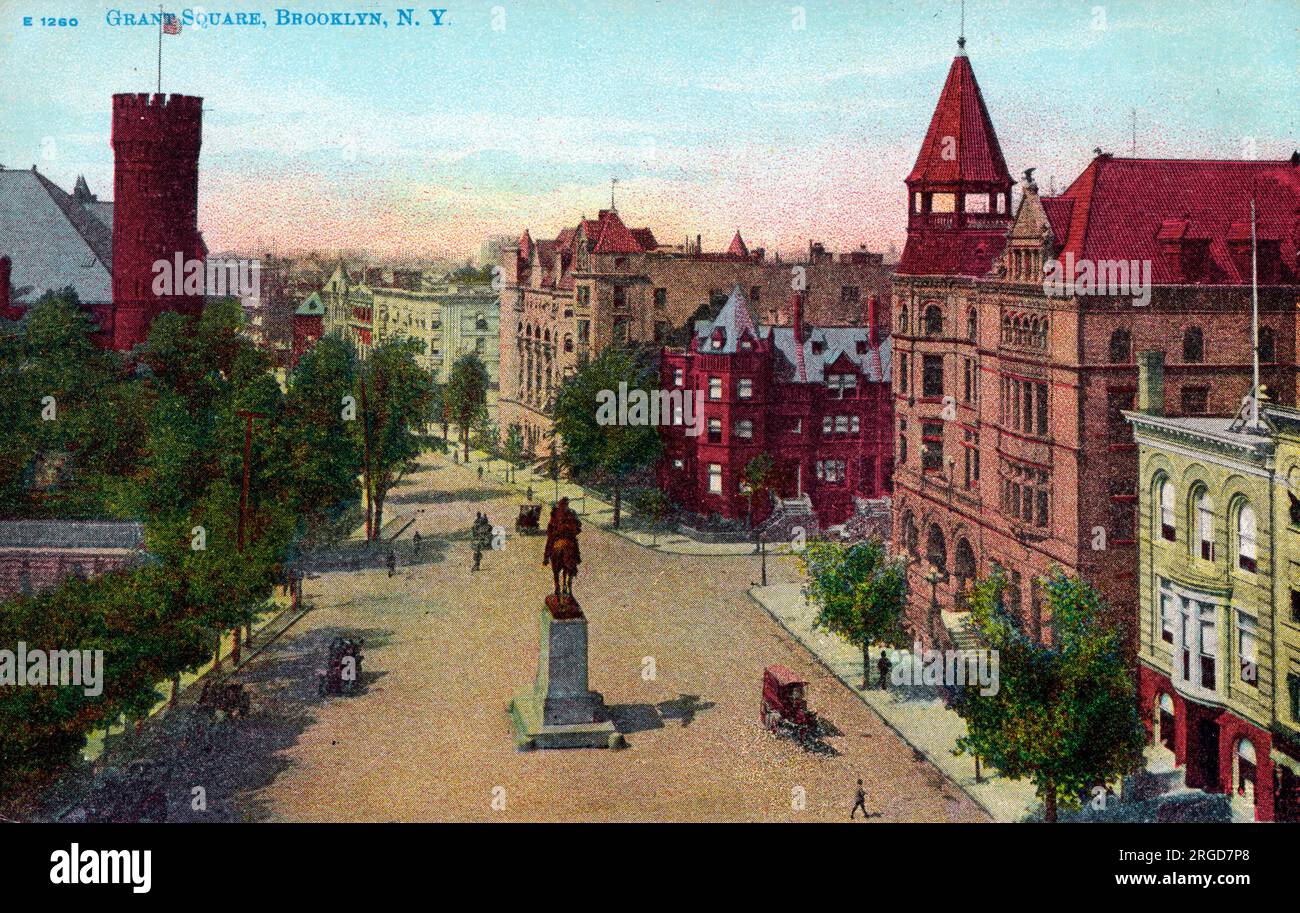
[[1128, 361, 1300, 822]]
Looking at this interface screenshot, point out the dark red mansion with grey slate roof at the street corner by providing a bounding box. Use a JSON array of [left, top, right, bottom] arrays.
[[659, 286, 893, 527]]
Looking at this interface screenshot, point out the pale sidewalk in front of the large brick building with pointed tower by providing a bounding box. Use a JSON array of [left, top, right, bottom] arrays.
[[749, 583, 1041, 822]]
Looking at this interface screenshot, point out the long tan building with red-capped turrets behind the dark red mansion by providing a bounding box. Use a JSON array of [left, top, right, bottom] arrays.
[[499, 209, 889, 453]]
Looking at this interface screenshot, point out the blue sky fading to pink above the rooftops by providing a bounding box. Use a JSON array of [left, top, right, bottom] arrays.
[[0, 0, 1300, 259]]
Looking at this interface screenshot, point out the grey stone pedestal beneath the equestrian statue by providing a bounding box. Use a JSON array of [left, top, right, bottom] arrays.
[[510, 594, 623, 749]]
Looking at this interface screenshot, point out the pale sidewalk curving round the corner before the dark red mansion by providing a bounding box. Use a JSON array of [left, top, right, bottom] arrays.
[[433, 447, 789, 558]]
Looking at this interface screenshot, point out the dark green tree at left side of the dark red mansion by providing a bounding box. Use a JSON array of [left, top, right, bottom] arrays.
[[555, 346, 663, 529]]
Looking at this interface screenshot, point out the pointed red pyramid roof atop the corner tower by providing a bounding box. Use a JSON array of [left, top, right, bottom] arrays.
[[906, 53, 1011, 185]]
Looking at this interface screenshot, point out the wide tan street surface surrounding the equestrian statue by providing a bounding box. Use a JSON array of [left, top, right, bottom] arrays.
[[116, 458, 987, 822]]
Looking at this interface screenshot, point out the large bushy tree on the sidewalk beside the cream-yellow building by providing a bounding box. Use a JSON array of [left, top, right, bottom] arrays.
[[954, 568, 1145, 822]]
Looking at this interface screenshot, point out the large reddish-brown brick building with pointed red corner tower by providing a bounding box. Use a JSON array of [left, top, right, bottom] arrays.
[[893, 37, 1300, 650]]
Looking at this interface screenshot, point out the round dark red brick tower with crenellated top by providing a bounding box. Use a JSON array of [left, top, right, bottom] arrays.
[[104, 94, 203, 351]]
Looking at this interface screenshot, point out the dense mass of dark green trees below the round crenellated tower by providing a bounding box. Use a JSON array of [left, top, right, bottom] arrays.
[[0, 293, 371, 796]]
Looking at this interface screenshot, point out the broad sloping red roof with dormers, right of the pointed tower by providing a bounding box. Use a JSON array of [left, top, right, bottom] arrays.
[[1043, 155, 1300, 285]]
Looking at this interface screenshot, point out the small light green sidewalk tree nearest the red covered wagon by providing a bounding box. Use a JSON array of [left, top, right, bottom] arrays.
[[800, 538, 907, 688]]
